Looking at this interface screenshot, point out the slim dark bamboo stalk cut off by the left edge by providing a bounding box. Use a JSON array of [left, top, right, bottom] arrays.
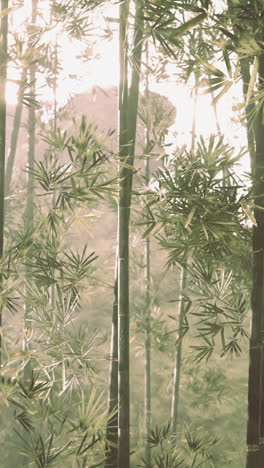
[[0, 0, 8, 373]]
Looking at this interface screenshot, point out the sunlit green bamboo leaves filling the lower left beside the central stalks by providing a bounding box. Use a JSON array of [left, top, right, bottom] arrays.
[[1, 114, 114, 467]]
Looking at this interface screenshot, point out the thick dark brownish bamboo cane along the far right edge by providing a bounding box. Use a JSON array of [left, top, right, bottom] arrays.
[[246, 54, 264, 468]]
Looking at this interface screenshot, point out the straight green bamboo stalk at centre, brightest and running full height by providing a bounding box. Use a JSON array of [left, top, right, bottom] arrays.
[[118, 0, 130, 468]]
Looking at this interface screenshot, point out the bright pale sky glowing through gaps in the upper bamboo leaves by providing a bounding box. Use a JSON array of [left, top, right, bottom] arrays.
[[7, 0, 249, 174]]
